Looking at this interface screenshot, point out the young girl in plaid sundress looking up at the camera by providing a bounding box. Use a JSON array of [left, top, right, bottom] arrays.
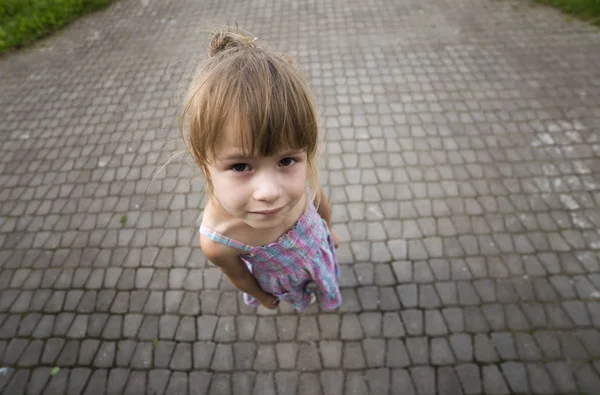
[[182, 29, 342, 310]]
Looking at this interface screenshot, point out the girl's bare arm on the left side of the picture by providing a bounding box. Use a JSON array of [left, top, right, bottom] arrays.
[[200, 236, 279, 309]]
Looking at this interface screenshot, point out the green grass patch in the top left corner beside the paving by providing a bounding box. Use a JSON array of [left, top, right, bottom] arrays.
[[0, 0, 112, 53]]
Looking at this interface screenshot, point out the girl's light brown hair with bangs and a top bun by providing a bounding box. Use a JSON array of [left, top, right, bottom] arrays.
[[181, 28, 320, 205]]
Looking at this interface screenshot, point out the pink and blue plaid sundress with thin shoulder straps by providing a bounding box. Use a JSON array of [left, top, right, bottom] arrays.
[[200, 204, 342, 310]]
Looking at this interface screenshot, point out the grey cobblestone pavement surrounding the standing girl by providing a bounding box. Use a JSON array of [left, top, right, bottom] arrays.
[[0, 0, 600, 395]]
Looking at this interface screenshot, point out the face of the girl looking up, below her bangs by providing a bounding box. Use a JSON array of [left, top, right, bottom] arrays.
[[208, 124, 308, 229]]
